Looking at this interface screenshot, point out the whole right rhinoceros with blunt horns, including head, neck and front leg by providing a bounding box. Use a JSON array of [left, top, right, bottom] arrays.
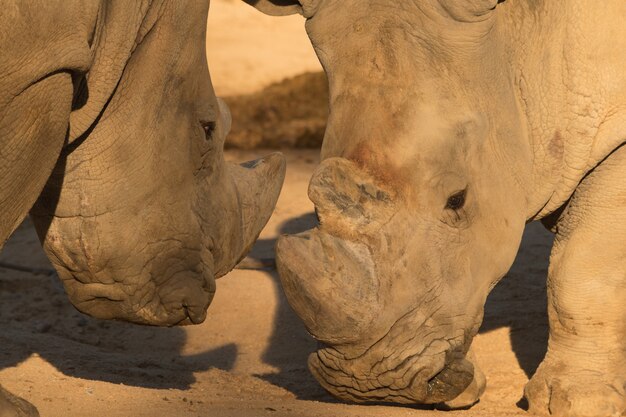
[[246, 0, 626, 416]]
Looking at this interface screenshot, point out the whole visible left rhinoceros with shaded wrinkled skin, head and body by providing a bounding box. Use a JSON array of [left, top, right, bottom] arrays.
[[0, 0, 285, 417]]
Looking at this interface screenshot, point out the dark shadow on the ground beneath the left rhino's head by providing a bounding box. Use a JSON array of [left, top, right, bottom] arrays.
[[0, 221, 238, 389]]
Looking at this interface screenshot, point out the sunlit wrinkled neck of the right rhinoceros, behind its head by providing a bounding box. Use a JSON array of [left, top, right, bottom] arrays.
[[499, 0, 626, 219]]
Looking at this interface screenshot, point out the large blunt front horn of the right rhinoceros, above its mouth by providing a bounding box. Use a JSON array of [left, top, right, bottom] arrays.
[[276, 229, 381, 344]]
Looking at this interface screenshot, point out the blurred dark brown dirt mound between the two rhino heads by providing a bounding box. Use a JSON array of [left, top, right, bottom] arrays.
[[224, 72, 328, 149]]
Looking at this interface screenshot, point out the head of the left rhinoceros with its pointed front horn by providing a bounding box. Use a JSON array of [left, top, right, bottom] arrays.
[[31, 2, 285, 325]]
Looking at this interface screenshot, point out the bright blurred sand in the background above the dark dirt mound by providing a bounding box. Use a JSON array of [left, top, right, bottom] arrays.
[[207, 0, 322, 97]]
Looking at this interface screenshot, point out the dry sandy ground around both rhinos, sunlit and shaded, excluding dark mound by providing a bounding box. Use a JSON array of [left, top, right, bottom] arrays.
[[0, 0, 551, 417]]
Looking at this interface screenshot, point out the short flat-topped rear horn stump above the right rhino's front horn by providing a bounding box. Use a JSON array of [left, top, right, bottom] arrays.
[[309, 158, 392, 232]]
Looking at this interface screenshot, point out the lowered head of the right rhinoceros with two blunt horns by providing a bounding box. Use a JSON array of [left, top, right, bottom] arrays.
[[246, 0, 530, 403]]
